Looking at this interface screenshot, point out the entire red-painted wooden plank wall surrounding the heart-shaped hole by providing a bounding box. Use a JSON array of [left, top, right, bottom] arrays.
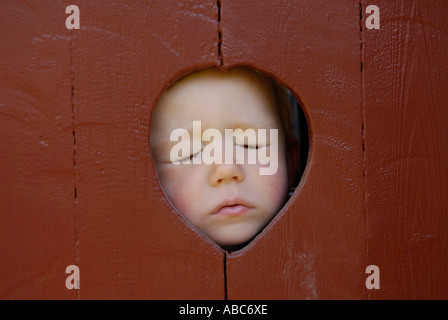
[[0, 0, 448, 299]]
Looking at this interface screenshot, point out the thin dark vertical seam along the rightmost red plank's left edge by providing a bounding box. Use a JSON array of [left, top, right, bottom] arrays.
[[359, 0, 369, 299]]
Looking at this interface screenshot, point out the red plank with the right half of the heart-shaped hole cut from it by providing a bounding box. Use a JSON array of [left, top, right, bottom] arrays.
[[221, 0, 366, 299]]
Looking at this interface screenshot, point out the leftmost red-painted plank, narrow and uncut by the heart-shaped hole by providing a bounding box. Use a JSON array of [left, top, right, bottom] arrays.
[[0, 0, 77, 299]]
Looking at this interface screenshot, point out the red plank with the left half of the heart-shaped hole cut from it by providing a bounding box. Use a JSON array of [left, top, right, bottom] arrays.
[[73, 0, 224, 299]]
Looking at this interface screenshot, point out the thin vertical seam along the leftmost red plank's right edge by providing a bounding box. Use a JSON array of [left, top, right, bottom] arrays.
[[70, 26, 80, 300]]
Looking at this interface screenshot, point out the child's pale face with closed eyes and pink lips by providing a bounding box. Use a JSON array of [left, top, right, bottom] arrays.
[[151, 69, 288, 246]]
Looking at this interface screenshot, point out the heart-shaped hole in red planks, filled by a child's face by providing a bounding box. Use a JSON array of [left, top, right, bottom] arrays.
[[150, 67, 308, 251]]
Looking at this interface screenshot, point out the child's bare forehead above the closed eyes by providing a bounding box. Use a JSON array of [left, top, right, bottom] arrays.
[[153, 68, 279, 136]]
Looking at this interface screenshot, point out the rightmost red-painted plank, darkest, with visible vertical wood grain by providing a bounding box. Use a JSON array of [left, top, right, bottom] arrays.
[[362, 0, 448, 299]]
